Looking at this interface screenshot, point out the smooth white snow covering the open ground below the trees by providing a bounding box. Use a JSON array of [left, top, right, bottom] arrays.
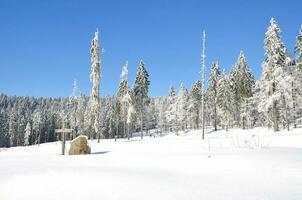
[[0, 128, 302, 200]]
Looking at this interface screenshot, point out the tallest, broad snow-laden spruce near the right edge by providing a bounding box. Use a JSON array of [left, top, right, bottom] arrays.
[[259, 18, 286, 131]]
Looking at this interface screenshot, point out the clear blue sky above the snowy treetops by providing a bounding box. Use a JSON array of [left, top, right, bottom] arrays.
[[0, 0, 302, 97]]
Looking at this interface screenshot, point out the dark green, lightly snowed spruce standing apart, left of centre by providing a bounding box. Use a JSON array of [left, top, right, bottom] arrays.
[[133, 60, 150, 139]]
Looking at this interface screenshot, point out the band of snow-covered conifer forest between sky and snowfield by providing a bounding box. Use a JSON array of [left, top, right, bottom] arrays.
[[0, 18, 302, 147]]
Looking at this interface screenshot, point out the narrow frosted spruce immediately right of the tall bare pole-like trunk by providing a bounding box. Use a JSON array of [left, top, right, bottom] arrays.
[[207, 62, 220, 131]]
